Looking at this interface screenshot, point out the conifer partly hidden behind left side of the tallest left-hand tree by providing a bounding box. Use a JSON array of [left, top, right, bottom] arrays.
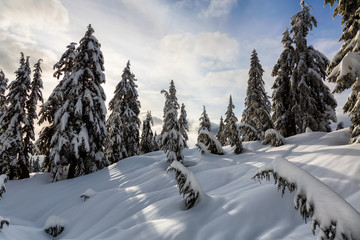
[[36, 43, 76, 172]]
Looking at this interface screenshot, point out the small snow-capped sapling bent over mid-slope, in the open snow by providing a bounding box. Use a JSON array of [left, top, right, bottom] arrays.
[[166, 161, 205, 209]]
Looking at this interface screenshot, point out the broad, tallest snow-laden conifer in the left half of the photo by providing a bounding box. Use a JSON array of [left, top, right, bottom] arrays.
[[50, 25, 109, 181]]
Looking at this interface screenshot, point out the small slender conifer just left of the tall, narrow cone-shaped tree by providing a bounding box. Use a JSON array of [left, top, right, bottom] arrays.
[[224, 95, 241, 146]]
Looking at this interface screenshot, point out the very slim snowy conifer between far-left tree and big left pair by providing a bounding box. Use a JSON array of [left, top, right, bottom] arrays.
[[24, 59, 44, 158]]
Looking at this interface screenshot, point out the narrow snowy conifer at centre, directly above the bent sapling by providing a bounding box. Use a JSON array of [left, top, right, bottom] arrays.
[[161, 81, 185, 164]]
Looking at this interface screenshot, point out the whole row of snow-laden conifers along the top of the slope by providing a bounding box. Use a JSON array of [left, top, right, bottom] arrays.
[[0, 0, 360, 181]]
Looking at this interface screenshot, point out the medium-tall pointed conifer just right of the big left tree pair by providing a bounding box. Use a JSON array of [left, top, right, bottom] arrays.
[[106, 61, 140, 163]]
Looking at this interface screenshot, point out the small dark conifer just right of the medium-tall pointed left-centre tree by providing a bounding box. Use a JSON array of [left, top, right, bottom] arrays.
[[140, 111, 156, 154]]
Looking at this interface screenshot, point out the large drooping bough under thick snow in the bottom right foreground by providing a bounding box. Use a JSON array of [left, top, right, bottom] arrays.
[[253, 158, 360, 240]]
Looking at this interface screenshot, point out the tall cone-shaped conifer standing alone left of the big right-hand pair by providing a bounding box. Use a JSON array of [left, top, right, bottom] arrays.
[[241, 49, 272, 141]]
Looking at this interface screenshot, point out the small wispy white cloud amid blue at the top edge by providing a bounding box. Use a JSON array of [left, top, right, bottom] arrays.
[[198, 0, 236, 18]]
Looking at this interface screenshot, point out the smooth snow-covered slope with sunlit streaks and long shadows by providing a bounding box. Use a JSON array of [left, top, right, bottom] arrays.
[[0, 129, 360, 240]]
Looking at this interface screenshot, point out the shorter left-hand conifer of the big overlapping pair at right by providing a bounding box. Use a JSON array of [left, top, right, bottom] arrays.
[[271, 29, 296, 137]]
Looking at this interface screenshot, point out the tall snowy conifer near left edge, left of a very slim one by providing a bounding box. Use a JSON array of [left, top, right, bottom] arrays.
[[0, 53, 31, 179]]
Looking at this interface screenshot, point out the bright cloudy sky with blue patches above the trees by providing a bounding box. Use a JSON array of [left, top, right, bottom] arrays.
[[0, 0, 349, 141]]
